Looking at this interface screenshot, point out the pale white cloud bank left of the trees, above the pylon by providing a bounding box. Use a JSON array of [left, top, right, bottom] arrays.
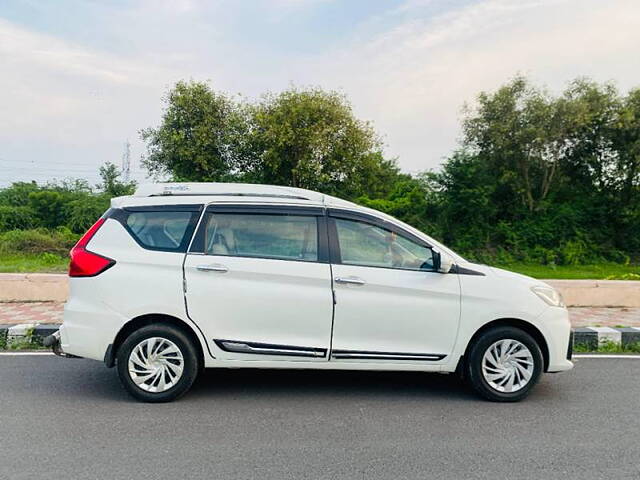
[[0, 16, 180, 186]]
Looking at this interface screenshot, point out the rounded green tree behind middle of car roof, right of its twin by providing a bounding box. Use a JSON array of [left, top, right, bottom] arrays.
[[247, 88, 395, 196]]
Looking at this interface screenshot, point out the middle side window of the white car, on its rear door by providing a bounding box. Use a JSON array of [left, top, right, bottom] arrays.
[[204, 212, 318, 262]]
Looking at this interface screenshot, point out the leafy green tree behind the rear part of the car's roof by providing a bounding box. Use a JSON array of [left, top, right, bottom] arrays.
[[141, 81, 249, 182]]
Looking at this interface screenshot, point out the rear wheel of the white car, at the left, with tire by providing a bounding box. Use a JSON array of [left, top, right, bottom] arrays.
[[116, 324, 200, 403]]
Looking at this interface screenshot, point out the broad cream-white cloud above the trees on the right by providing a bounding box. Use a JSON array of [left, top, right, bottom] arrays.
[[305, 0, 640, 171]]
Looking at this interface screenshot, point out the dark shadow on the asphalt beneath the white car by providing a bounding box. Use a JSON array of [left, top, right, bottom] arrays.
[[18, 358, 561, 403]]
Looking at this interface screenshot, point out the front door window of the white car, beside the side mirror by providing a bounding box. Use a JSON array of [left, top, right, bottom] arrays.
[[335, 218, 433, 270]]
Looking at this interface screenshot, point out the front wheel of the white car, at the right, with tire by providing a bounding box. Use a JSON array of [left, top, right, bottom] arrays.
[[464, 327, 544, 402]]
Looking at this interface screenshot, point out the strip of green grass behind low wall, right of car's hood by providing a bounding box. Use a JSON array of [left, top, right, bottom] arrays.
[[495, 263, 640, 280]]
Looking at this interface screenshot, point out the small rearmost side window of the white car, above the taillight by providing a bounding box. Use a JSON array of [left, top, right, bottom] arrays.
[[113, 206, 200, 252]]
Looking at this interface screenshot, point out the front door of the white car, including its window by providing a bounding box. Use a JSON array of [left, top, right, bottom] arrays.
[[328, 210, 460, 363]]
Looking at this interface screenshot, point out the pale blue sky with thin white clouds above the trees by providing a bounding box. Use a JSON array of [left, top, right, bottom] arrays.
[[0, 0, 640, 187]]
